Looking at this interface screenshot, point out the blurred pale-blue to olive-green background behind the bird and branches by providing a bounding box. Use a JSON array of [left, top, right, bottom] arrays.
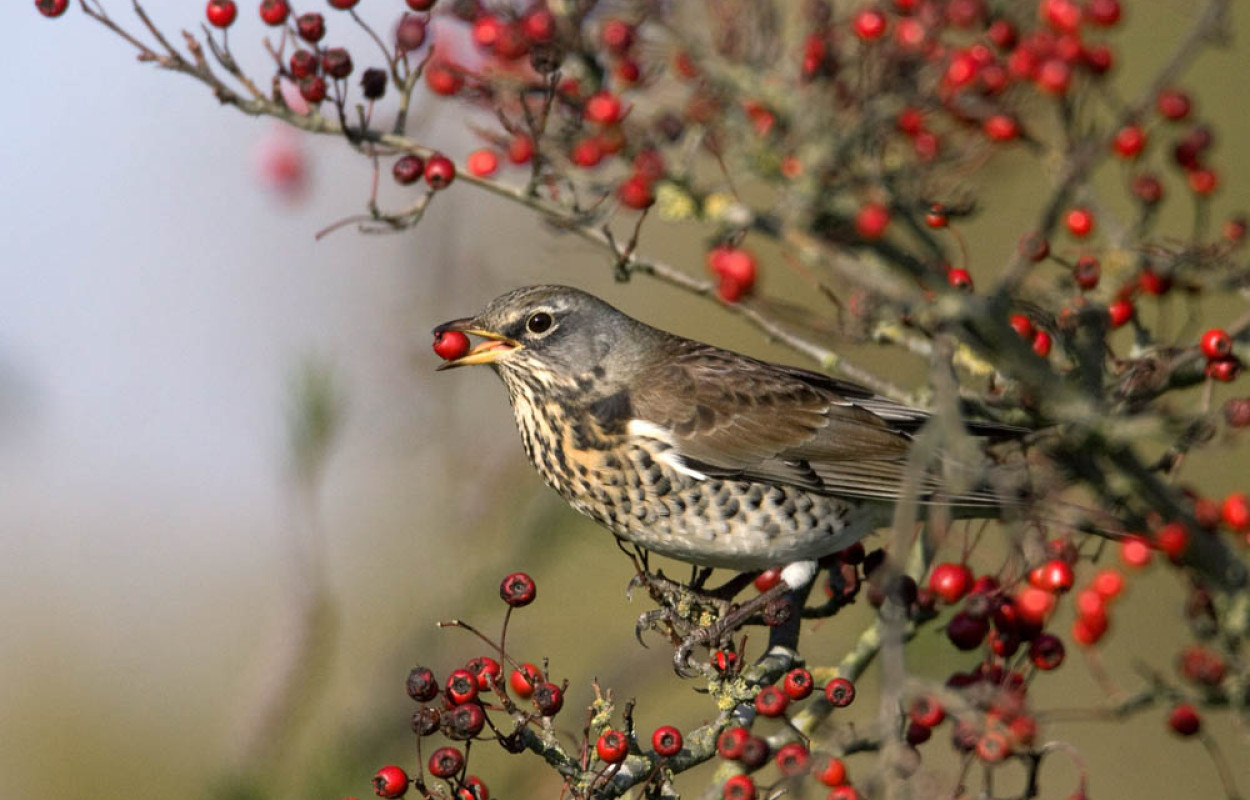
[[0, 0, 1250, 800]]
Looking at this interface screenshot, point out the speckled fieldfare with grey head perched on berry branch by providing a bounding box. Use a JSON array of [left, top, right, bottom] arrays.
[[434, 286, 1020, 586]]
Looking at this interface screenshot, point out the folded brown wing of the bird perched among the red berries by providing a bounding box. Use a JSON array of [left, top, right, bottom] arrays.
[[630, 343, 1000, 500]]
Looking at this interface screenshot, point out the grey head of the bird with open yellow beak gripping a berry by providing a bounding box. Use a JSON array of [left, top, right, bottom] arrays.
[[434, 285, 659, 384]]
